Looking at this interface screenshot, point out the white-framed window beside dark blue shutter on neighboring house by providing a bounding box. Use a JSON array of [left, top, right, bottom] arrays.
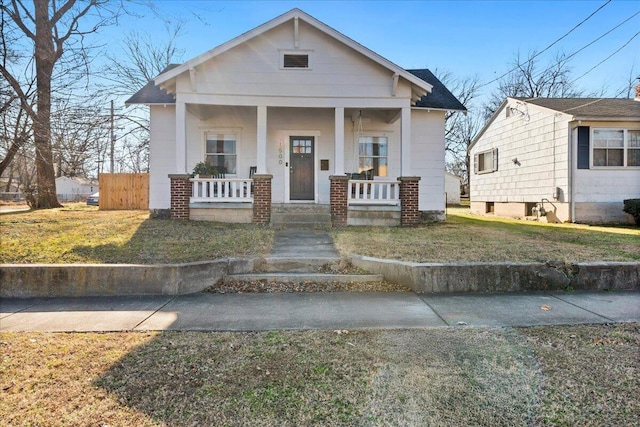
[[591, 128, 640, 167]]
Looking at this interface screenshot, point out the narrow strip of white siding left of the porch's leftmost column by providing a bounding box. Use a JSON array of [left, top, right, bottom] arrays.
[[149, 105, 176, 209]]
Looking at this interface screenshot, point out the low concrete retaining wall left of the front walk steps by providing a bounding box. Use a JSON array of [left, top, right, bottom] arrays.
[[0, 259, 253, 298]]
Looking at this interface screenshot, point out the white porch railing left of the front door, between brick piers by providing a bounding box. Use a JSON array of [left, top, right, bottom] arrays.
[[189, 178, 253, 203]]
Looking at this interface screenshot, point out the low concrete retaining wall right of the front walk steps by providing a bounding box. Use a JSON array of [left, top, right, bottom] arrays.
[[351, 256, 640, 293]]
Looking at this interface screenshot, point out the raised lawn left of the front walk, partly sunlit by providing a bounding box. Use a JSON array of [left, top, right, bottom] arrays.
[[0, 204, 273, 264]]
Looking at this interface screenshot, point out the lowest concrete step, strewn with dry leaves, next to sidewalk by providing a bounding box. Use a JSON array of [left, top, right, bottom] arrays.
[[224, 273, 384, 285]]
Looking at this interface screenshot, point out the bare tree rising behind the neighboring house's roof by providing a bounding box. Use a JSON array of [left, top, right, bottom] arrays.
[[484, 51, 583, 119]]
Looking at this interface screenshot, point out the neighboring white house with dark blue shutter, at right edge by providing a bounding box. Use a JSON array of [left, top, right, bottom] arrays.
[[469, 95, 640, 223]]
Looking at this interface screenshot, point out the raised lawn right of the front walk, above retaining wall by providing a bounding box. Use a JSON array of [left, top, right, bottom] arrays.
[[332, 208, 640, 262]]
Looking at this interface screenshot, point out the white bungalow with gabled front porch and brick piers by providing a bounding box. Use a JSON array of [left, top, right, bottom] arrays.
[[127, 9, 465, 225]]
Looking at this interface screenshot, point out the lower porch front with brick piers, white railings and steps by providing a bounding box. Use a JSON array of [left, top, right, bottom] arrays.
[[169, 174, 420, 226]]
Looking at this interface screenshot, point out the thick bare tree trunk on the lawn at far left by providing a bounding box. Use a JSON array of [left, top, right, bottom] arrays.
[[33, 0, 62, 209]]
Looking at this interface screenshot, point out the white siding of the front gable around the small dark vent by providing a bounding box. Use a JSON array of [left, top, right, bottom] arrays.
[[177, 21, 410, 103]]
